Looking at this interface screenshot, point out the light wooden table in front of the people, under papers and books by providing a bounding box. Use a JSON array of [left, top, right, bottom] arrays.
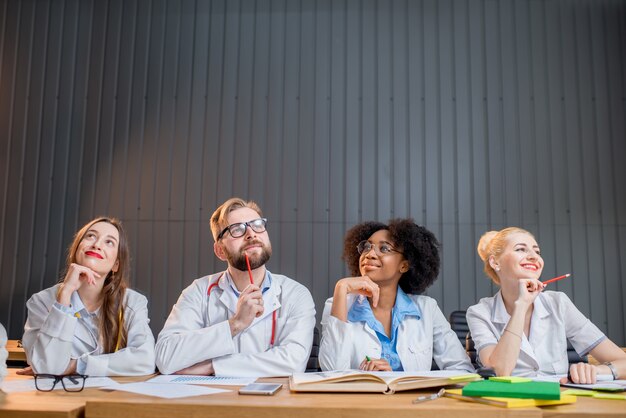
[[0, 369, 626, 418]]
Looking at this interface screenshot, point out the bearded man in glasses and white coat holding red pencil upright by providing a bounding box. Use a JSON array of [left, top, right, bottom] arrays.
[[156, 198, 315, 377]]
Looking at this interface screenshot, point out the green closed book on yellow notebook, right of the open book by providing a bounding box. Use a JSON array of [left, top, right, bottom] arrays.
[[463, 380, 561, 400]]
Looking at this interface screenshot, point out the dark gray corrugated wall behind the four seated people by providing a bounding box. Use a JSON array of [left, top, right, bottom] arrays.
[[0, 0, 626, 345]]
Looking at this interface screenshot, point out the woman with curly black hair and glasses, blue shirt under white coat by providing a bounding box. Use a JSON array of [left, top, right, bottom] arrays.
[[319, 219, 474, 371]]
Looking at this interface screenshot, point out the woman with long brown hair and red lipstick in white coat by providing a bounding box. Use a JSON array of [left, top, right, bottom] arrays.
[[22, 217, 154, 376]]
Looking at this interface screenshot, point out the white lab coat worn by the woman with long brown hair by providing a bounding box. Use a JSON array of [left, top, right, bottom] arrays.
[[22, 285, 154, 376]]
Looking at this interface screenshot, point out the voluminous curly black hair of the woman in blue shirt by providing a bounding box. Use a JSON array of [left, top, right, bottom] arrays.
[[342, 218, 440, 295]]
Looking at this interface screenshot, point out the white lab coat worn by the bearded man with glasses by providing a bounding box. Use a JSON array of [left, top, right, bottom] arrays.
[[156, 271, 315, 377]]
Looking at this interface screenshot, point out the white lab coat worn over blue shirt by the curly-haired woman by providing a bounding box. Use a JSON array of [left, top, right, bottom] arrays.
[[319, 295, 474, 372]]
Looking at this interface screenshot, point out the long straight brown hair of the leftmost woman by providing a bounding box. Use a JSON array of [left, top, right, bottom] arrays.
[[61, 216, 130, 353]]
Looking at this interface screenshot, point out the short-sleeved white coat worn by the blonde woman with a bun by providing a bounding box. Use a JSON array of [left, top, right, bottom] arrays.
[[467, 291, 606, 376]]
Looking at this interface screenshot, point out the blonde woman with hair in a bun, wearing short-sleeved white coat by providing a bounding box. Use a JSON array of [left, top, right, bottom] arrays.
[[467, 228, 626, 383]]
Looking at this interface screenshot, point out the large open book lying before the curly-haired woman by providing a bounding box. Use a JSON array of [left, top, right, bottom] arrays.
[[289, 370, 480, 393]]
